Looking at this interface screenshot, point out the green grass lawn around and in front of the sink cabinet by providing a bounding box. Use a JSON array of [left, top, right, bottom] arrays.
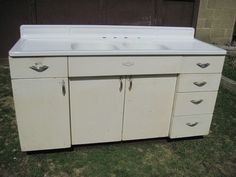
[[0, 66, 236, 177]]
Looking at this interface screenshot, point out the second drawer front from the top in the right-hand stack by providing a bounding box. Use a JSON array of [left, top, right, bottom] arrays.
[[177, 74, 221, 92]]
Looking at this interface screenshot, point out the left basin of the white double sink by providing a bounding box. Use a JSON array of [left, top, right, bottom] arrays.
[[71, 42, 116, 51]]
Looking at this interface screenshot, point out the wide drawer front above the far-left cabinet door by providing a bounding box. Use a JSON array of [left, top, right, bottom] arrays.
[[9, 57, 68, 79]]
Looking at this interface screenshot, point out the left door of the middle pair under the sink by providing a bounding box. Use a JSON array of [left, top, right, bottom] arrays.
[[70, 77, 124, 144]]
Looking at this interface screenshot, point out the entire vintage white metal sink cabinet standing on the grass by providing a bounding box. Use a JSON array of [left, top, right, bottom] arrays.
[[9, 25, 226, 151]]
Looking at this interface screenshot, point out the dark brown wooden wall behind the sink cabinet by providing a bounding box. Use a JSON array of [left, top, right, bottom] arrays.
[[0, 0, 199, 60]]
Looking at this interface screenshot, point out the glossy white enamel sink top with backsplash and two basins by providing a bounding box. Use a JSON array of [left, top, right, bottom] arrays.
[[9, 25, 226, 57]]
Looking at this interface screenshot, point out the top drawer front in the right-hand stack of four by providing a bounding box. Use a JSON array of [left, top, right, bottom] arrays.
[[181, 56, 225, 73]]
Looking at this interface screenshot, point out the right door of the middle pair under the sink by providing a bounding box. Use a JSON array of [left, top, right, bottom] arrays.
[[123, 76, 176, 140]]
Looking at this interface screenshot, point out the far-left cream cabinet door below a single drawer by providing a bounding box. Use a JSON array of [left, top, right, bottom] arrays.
[[12, 78, 71, 151]]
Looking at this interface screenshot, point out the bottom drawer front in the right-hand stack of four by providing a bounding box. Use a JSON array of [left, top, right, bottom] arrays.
[[170, 114, 212, 138]]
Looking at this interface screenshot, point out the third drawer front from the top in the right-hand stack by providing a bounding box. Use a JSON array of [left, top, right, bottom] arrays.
[[174, 92, 217, 116]]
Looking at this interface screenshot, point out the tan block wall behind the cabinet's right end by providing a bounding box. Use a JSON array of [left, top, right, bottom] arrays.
[[196, 0, 236, 44]]
